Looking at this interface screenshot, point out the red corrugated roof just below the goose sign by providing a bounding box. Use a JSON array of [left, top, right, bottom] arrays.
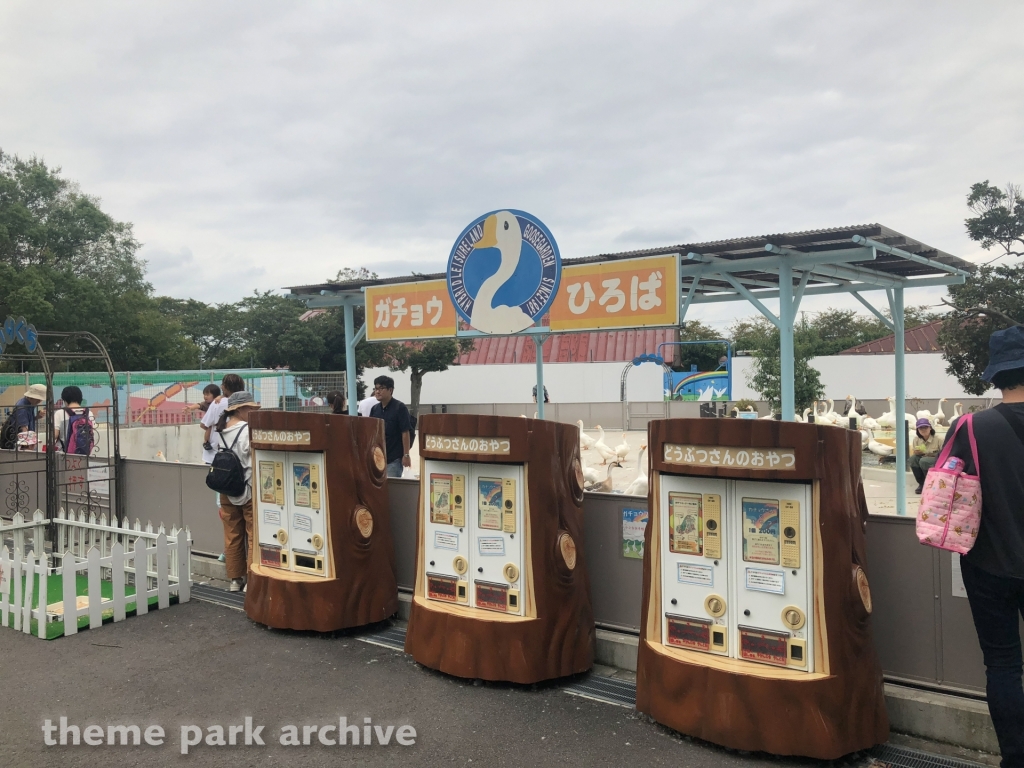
[[459, 328, 679, 366]]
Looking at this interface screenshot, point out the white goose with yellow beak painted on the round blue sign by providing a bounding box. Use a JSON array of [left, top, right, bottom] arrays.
[[469, 211, 534, 334]]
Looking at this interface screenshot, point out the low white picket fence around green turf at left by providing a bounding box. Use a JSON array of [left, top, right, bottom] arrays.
[[0, 510, 191, 637]]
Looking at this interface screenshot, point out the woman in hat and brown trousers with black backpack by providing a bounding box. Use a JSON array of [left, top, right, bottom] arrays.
[[207, 392, 259, 592]]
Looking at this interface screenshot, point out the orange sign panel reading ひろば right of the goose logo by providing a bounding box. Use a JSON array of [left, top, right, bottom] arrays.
[[551, 255, 679, 331]]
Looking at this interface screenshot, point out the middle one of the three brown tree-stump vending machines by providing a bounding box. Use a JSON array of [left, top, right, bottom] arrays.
[[406, 414, 596, 683]]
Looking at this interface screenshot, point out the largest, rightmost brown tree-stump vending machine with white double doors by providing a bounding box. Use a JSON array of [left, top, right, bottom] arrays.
[[637, 419, 889, 760]]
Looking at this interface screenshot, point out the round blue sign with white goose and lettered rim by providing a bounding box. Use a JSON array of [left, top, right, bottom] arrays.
[[447, 208, 562, 335]]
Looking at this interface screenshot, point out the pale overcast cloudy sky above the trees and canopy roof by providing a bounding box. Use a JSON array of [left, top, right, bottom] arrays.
[[0, 0, 1024, 327]]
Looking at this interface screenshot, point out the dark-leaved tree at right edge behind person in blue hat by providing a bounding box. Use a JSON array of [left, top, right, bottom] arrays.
[[939, 181, 1024, 395]]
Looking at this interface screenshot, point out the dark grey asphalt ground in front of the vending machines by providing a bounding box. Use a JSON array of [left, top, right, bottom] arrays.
[[0, 600, 868, 768]]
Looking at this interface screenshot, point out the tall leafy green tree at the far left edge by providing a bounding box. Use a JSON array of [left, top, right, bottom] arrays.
[[0, 151, 198, 370]]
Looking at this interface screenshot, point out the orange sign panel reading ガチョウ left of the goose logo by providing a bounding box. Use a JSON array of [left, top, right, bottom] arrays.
[[366, 280, 456, 341]]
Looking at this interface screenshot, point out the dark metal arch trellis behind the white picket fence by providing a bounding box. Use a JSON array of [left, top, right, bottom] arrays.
[[0, 331, 125, 541]]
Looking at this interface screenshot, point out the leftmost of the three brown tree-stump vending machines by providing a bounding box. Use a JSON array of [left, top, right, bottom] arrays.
[[246, 411, 398, 632]]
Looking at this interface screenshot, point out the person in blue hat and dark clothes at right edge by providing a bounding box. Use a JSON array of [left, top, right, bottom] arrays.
[[946, 326, 1024, 768]]
